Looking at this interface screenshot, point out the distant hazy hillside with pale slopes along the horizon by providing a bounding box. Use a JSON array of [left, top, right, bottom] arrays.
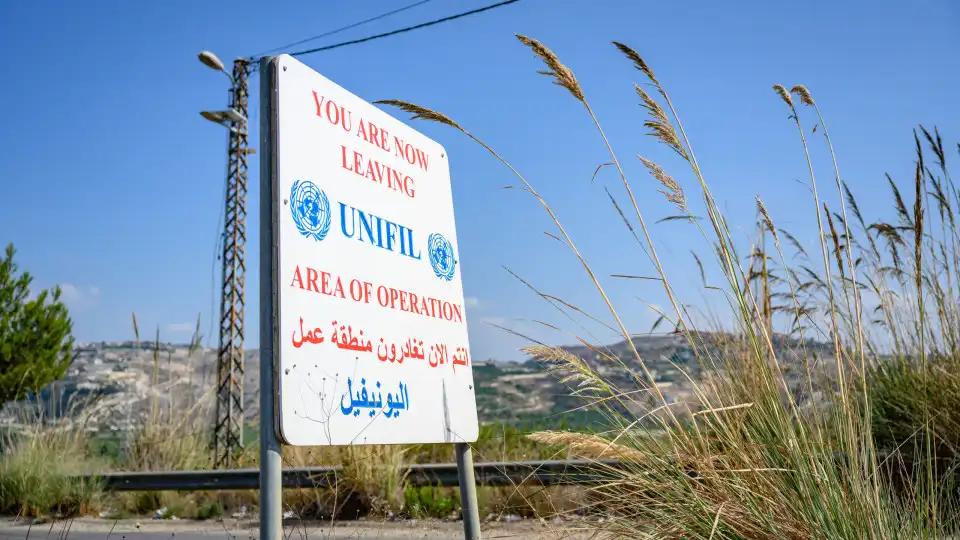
[[0, 334, 831, 434]]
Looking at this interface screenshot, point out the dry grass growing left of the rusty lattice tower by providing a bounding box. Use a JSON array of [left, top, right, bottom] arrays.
[[0, 315, 215, 517]]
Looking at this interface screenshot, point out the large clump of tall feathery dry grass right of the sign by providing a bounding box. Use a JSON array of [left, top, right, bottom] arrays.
[[380, 36, 960, 540]]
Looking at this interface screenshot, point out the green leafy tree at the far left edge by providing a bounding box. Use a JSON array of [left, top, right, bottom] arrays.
[[0, 244, 73, 404]]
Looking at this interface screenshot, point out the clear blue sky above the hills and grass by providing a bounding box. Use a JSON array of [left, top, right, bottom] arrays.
[[0, 0, 960, 359]]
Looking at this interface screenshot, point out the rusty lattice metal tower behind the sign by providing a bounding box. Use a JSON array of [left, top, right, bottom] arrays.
[[213, 59, 253, 468]]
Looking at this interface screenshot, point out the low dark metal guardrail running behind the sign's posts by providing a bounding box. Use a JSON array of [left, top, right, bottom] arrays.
[[83, 460, 621, 491]]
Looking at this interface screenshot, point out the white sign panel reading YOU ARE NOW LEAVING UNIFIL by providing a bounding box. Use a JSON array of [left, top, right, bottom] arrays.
[[273, 55, 478, 446]]
